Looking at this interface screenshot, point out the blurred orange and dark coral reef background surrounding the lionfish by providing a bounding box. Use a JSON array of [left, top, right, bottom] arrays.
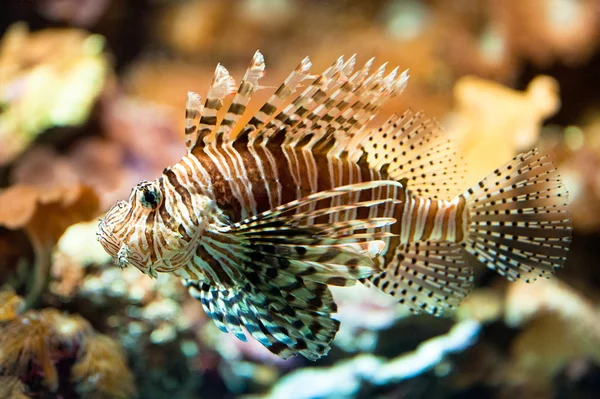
[[0, 0, 600, 399]]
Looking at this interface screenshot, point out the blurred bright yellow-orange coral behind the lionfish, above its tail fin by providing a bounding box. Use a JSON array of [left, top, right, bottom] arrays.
[[448, 76, 560, 186]]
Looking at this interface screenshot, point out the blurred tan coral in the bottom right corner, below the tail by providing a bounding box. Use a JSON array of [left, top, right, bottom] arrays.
[[478, 279, 600, 393]]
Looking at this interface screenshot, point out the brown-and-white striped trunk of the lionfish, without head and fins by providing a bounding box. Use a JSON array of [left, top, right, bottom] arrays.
[[155, 146, 467, 285]]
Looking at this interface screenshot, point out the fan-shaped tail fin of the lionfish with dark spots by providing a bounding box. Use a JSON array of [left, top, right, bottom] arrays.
[[463, 150, 572, 282]]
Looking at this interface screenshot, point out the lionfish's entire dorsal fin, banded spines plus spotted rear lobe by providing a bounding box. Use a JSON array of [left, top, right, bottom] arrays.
[[186, 52, 464, 199]]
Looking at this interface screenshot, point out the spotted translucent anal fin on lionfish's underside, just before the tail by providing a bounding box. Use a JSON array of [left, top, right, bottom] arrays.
[[367, 242, 473, 315]]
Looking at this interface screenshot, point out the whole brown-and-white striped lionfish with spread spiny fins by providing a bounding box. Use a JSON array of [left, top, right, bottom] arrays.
[[98, 52, 571, 360]]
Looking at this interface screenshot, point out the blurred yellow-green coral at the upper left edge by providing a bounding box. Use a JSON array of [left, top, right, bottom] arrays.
[[0, 24, 108, 165]]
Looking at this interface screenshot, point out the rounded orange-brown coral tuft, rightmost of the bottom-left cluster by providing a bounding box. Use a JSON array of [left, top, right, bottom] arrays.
[[72, 334, 136, 398]]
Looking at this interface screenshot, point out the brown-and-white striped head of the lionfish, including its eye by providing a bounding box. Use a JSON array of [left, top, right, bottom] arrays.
[[96, 179, 192, 277]]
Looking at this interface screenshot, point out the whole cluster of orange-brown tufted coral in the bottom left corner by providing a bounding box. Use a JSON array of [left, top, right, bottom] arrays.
[[0, 294, 135, 398]]
